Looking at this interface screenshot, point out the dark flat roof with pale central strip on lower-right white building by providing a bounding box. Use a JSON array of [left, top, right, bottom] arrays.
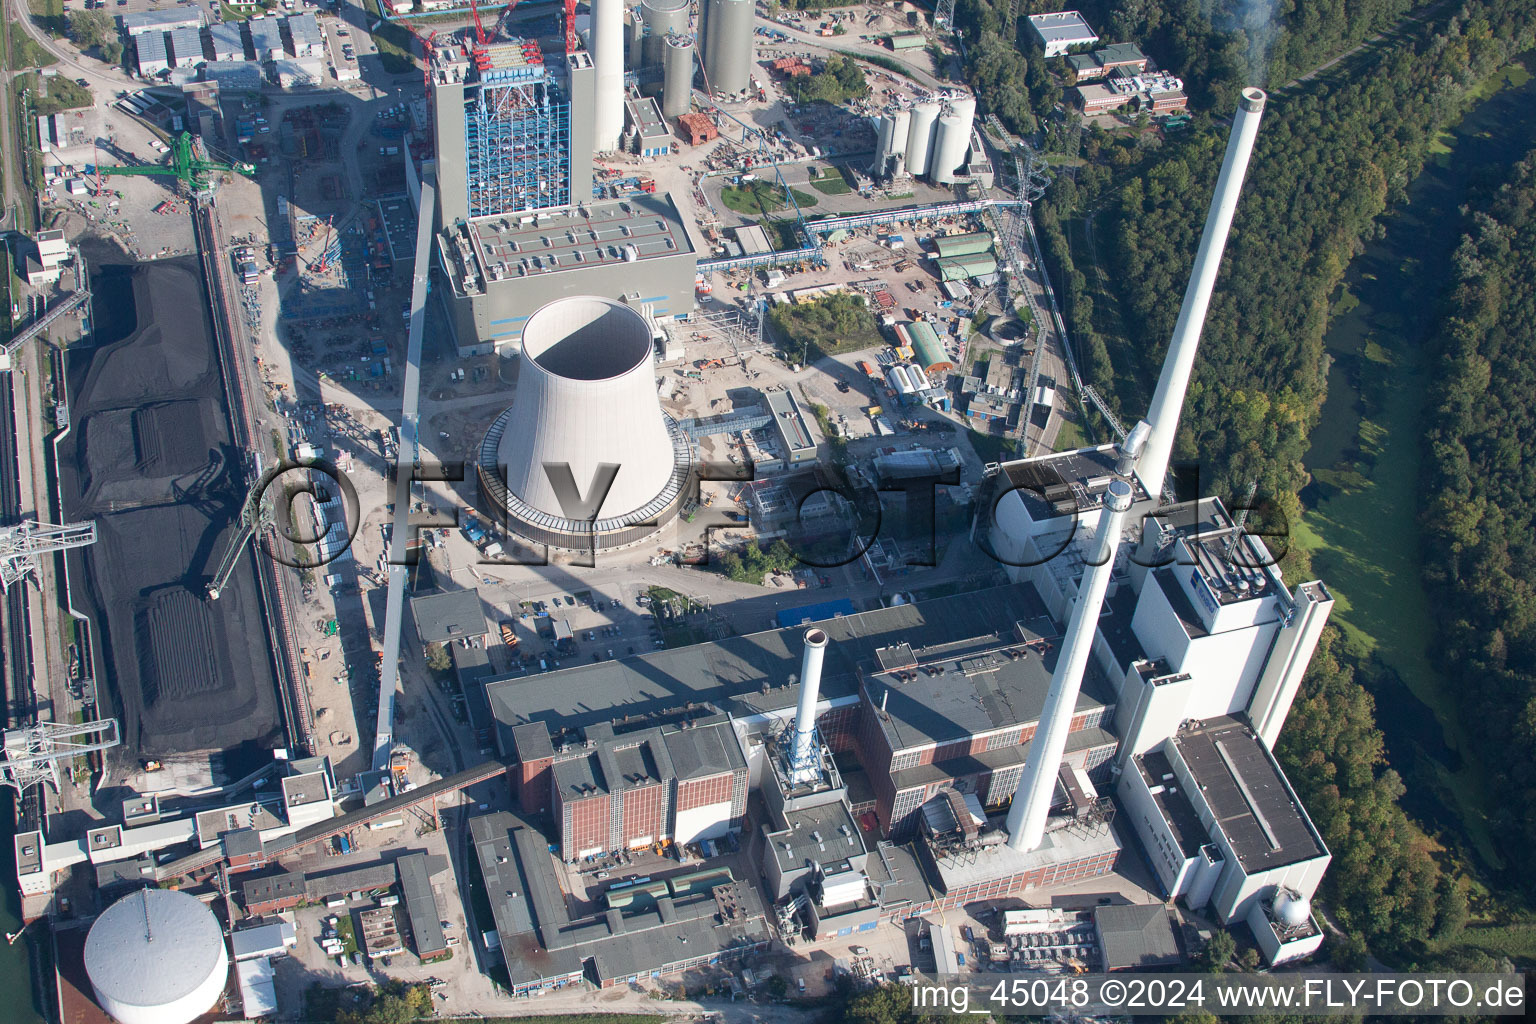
[[1174, 718, 1326, 874]]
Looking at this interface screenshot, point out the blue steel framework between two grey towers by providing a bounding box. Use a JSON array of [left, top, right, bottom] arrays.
[[464, 64, 573, 216]]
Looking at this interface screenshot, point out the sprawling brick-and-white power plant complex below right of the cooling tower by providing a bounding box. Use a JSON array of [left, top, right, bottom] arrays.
[[466, 91, 1333, 963]]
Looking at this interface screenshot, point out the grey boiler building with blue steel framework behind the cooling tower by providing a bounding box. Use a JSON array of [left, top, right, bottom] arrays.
[[432, 16, 697, 355]]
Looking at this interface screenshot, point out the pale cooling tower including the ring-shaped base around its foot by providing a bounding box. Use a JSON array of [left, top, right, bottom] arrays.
[[479, 296, 691, 551]]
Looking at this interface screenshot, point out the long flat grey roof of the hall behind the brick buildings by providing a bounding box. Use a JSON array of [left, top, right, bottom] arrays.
[[485, 583, 1043, 751]]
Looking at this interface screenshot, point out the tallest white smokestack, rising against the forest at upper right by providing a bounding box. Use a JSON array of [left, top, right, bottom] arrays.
[[1140, 89, 1266, 499]]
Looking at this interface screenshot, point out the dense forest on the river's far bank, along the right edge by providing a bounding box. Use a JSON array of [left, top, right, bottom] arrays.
[[1424, 150, 1536, 880]]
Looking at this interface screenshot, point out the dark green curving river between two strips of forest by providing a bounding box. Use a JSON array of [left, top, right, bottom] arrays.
[[1301, 54, 1536, 869]]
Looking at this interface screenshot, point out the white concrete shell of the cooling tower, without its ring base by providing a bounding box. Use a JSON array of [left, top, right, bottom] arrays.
[[498, 295, 676, 520]]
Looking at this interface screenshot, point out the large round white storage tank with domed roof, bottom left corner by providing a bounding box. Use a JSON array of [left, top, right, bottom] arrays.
[[84, 889, 229, 1024]]
